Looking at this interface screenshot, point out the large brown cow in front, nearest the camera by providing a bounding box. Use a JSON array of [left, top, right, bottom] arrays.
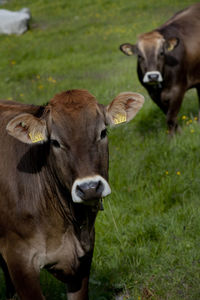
[[0, 90, 144, 300]]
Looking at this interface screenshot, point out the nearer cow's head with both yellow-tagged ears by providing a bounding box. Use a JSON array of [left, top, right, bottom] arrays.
[[6, 90, 144, 205]]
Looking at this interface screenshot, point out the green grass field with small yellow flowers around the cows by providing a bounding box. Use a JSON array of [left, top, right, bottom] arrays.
[[0, 0, 200, 300]]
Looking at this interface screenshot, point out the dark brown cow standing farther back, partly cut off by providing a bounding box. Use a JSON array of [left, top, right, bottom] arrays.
[[120, 3, 200, 133]]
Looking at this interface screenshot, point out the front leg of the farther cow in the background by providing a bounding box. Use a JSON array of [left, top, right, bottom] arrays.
[[162, 87, 184, 135]]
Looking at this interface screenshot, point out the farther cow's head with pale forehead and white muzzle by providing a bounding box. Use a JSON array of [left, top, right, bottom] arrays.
[[120, 31, 179, 84]]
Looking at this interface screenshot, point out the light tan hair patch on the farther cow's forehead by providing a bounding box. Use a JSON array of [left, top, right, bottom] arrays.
[[137, 31, 164, 56]]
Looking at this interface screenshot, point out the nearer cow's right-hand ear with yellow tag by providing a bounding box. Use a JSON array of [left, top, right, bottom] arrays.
[[106, 92, 144, 126]]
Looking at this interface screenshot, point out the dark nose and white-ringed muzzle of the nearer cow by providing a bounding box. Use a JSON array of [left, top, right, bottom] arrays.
[[71, 175, 111, 205]]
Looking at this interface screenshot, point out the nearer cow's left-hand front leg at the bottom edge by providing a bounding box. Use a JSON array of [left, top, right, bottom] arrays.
[[5, 251, 45, 300]]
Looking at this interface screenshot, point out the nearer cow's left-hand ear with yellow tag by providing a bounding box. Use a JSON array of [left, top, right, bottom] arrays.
[[6, 113, 48, 144]]
